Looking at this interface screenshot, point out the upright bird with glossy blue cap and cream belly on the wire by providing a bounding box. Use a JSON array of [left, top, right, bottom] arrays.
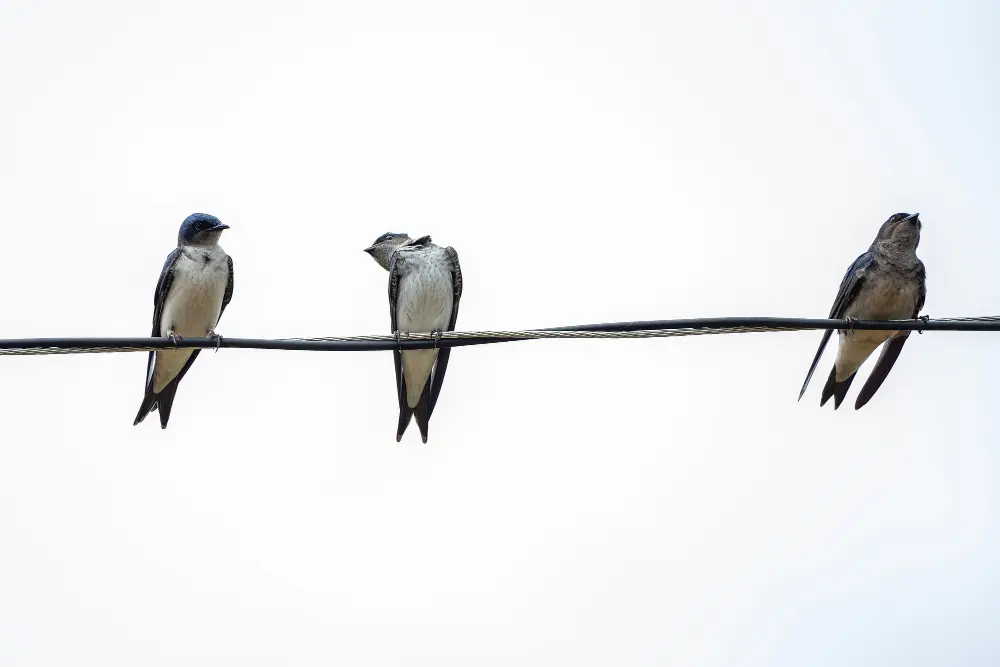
[[133, 213, 233, 428]]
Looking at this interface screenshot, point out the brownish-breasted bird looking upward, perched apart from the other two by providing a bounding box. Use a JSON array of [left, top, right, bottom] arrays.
[[799, 213, 928, 410]]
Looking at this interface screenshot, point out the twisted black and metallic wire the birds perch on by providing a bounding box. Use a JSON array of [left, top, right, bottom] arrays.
[[0, 315, 1000, 356]]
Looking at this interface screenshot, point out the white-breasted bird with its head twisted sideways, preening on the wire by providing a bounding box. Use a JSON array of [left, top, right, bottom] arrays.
[[365, 232, 462, 443]]
